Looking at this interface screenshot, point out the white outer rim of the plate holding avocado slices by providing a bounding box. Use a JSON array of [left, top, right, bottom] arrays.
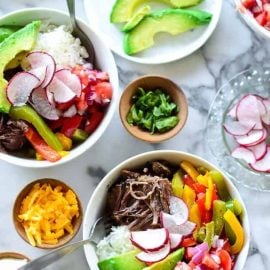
[[84, 0, 223, 65]]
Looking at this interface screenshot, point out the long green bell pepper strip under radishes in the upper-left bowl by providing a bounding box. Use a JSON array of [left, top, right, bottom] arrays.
[[9, 105, 63, 151]]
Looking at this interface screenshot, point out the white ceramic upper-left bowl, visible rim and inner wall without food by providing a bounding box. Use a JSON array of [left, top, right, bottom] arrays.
[[0, 8, 118, 168]]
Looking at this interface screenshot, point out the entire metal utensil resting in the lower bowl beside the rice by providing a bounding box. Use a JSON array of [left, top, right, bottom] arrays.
[[18, 216, 111, 270]]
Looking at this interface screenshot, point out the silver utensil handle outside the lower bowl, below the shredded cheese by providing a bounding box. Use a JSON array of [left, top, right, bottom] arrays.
[[18, 239, 92, 270]]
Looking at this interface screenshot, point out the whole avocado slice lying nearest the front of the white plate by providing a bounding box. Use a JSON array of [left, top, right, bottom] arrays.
[[124, 9, 212, 55]]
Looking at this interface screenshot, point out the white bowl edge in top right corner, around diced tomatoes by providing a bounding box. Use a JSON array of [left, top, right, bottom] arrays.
[[234, 0, 270, 38]]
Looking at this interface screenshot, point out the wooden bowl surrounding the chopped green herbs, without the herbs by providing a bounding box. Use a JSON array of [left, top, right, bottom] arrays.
[[119, 75, 188, 143]]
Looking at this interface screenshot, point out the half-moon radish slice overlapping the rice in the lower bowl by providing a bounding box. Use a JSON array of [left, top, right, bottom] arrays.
[[130, 228, 169, 251]]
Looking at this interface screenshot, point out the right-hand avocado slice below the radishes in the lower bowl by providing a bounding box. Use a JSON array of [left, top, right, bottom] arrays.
[[143, 248, 185, 270]]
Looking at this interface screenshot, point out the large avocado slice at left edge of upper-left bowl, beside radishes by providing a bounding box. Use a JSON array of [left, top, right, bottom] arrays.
[[0, 21, 41, 113]]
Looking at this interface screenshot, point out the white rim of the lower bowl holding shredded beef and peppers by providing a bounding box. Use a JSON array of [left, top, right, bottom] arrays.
[[83, 150, 251, 270]]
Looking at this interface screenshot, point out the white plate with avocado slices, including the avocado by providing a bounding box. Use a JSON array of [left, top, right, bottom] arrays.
[[84, 0, 222, 64]]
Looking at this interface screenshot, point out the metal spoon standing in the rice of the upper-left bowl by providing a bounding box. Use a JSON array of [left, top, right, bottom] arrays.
[[66, 0, 95, 68]]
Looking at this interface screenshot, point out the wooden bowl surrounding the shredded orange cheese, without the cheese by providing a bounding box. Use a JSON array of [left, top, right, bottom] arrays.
[[13, 178, 83, 249]]
